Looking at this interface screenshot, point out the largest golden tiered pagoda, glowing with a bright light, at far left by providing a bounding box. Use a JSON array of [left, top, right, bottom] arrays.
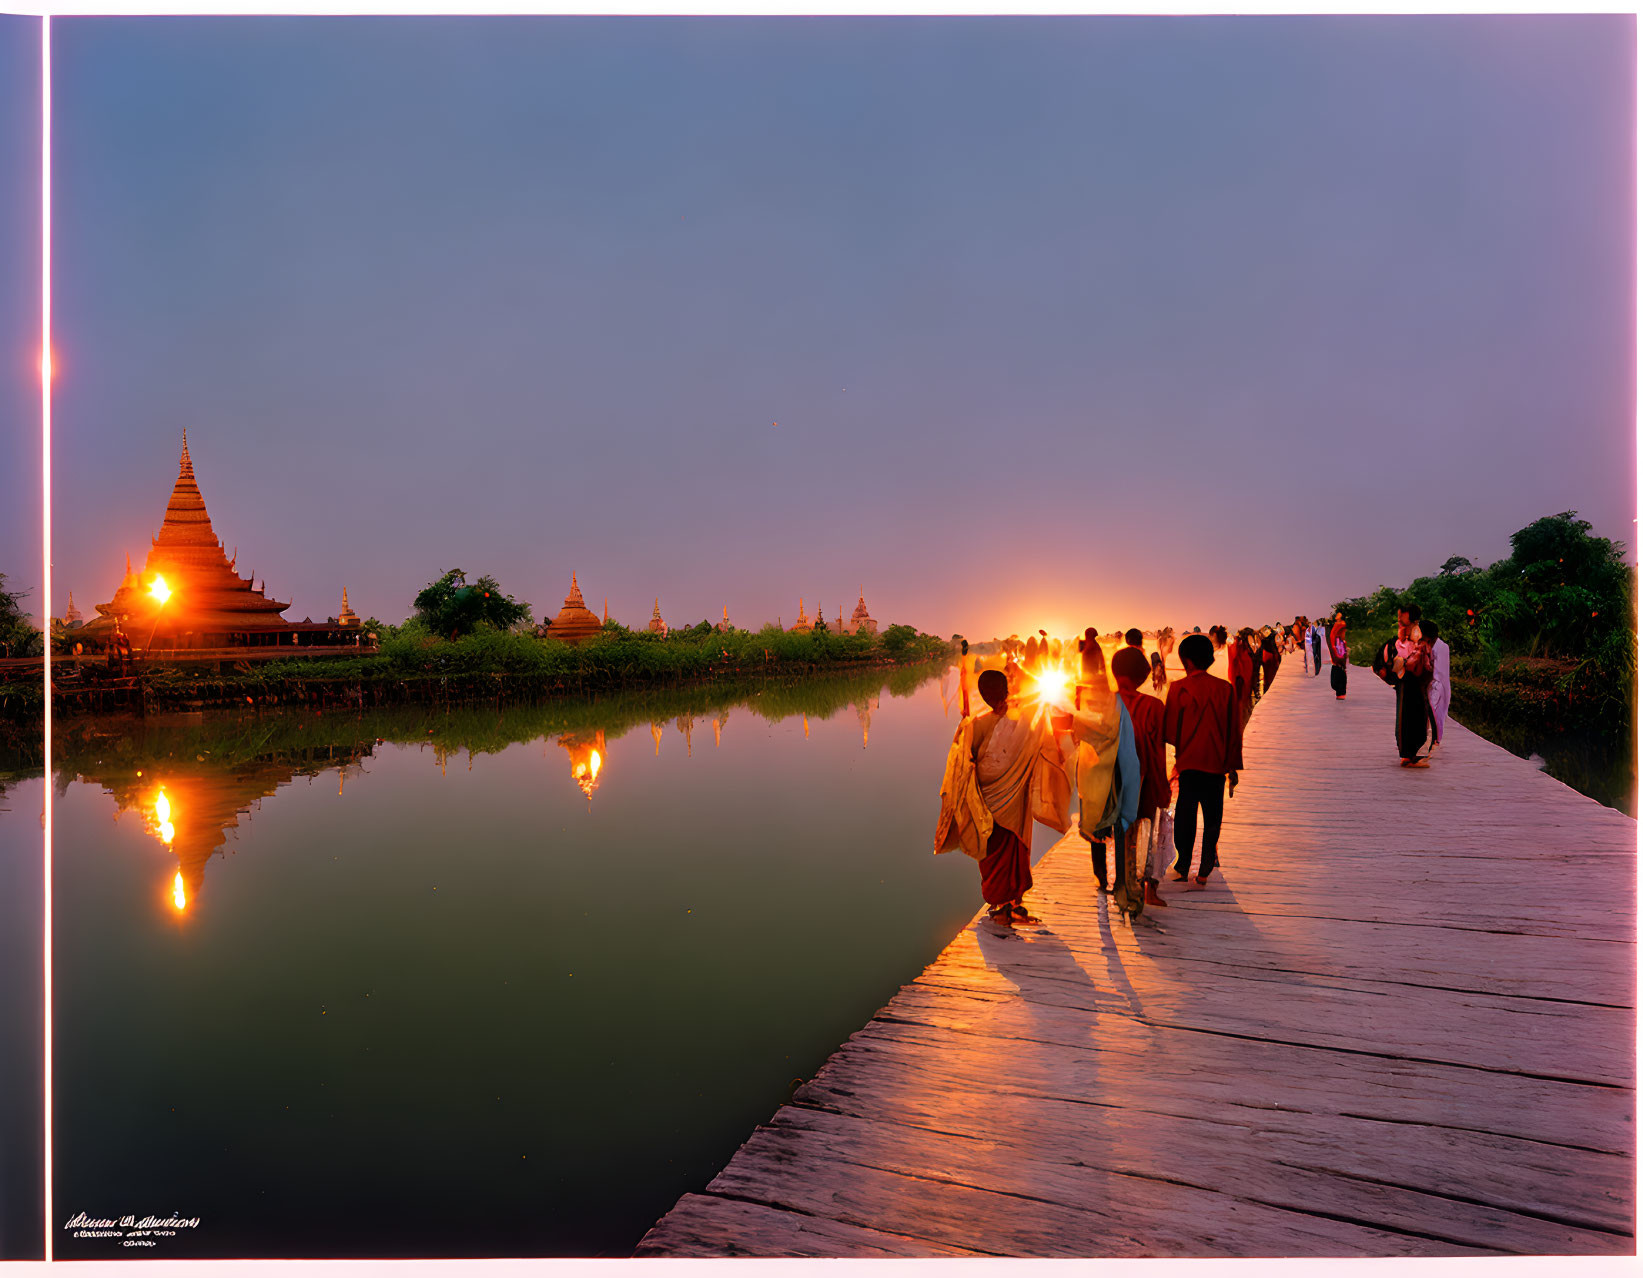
[[82, 430, 292, 647]]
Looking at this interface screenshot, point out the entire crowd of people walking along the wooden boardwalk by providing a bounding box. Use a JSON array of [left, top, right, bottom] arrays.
[[935, 608, 1449, 926]]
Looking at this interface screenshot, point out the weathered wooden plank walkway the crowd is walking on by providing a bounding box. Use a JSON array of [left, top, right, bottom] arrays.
[[637, 659, 1638, 1257]]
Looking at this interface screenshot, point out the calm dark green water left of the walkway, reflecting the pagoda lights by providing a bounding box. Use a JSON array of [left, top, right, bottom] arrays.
[[16, 673, 1048, 1258]]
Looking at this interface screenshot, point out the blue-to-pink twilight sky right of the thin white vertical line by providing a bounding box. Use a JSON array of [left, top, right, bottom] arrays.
[[41, 16, 1635, 637]]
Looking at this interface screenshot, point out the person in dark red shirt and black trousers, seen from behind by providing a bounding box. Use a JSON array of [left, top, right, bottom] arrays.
[[1163, 634, 1244, 884]]
